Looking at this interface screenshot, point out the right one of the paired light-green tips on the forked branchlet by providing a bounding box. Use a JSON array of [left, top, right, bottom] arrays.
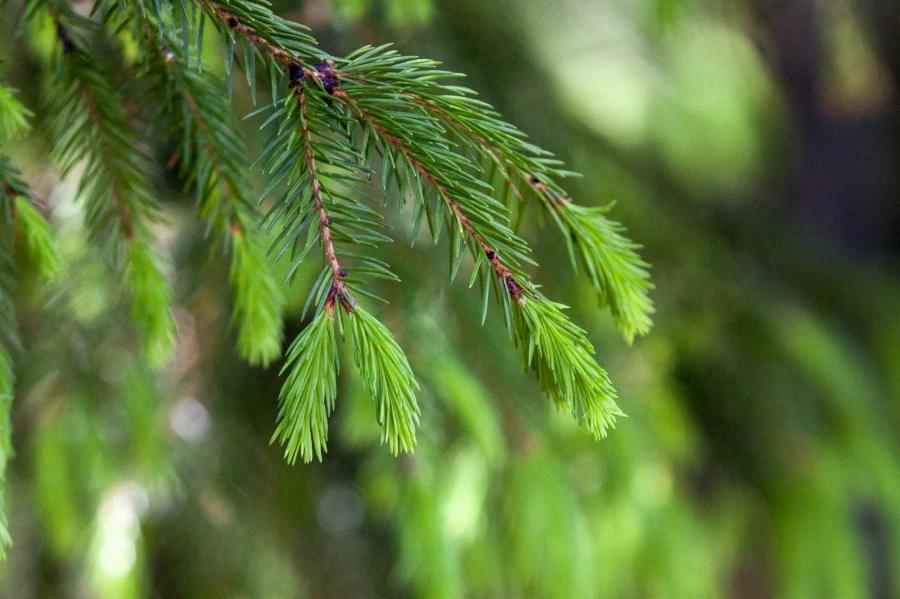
[[350, 307, 419, 455]]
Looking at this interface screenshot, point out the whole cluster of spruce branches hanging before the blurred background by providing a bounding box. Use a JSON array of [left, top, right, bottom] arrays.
[[0, 0, 653, 556]]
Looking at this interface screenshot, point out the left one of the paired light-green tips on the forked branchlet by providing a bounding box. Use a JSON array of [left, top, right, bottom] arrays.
[[272, 311, 340, 464]]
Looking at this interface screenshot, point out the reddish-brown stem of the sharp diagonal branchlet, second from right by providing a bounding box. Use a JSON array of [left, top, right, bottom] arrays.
[[334, 90, 525, 303]]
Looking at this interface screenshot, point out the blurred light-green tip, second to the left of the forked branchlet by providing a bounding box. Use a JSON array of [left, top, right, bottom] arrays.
[[125, 241, 175, 366]]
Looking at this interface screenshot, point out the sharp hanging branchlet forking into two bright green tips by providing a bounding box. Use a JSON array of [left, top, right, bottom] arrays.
[[263, 65, 419, 461]]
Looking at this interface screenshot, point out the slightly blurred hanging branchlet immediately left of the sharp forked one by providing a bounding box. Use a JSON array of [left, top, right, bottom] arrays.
[[133, 13, 284, 365]]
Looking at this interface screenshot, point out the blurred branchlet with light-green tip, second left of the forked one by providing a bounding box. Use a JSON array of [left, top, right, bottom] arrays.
[[46, 7, 175, 365]]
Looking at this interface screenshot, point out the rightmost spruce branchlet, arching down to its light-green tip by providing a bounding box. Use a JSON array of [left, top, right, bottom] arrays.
[[337, 47, 653, 342]]
